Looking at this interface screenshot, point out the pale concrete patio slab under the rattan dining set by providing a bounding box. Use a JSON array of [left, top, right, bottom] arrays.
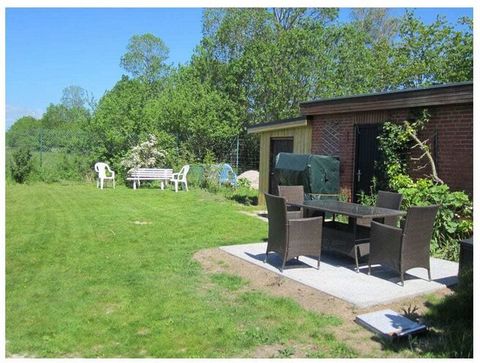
[[220, 242, 458, 308]]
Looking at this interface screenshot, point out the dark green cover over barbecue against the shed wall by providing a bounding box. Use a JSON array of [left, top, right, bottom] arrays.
[[274, 153, 340, 194]]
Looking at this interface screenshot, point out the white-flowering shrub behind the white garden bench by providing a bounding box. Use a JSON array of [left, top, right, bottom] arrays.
[[121, 134, 167, 170]]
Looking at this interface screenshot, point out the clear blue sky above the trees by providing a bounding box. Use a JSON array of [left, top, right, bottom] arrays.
[[5, 8, 472, 128]]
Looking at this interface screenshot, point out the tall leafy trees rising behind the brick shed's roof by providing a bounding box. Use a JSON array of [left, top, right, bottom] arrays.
[[196, 9, 473, 129]]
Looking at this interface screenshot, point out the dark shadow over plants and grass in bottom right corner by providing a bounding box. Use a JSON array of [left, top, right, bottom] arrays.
[[373, 270, 473, 358]]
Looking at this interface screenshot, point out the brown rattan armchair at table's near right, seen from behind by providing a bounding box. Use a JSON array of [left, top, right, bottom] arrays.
[[368, 205, 438, 286]]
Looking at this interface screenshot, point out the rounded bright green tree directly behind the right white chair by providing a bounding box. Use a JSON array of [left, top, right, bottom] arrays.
[[145, 68, 240, 160]]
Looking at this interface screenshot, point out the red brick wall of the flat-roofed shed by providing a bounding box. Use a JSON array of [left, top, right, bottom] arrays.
[[312, 104, 473, 200]]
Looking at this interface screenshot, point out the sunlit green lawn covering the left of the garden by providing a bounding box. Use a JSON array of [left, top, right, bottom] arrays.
[[6, 183, 355, 358]]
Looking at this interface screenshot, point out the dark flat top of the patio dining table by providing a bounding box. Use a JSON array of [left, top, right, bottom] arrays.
[[287, 200, 407, 218]]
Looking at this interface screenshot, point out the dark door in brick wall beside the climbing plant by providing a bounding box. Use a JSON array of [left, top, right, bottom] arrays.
[[353, 124, 386, 201]]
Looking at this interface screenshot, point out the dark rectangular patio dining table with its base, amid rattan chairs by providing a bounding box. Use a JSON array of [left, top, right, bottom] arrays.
[[287, 200, 406, 272]]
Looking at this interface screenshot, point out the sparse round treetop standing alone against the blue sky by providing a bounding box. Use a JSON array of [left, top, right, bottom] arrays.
[[120, 33, 169, 83]]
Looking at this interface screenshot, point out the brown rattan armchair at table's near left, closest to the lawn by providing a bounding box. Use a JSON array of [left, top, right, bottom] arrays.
[[264, 193, 323, 272]]
